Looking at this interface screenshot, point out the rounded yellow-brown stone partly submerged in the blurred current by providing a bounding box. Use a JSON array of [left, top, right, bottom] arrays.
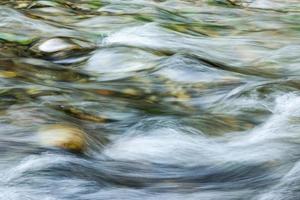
[[38, 124, 87, 153]]
